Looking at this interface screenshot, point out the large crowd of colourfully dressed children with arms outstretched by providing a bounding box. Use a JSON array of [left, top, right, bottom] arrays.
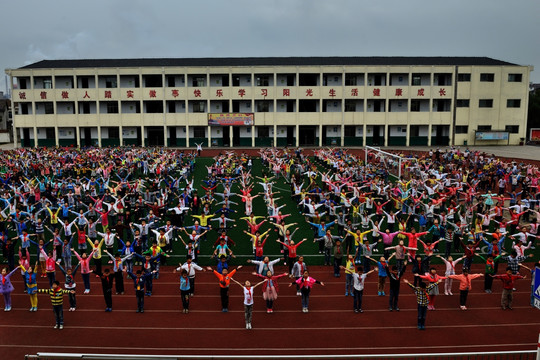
[[0, 148, 540, 329]]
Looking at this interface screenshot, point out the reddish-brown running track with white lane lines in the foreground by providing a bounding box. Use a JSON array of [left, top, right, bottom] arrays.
[[0, 265, 540, 359]]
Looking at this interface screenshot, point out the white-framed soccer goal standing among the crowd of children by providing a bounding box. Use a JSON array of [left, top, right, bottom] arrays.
[[364, 146, 418, 179]]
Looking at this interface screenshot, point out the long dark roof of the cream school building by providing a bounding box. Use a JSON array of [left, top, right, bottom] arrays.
[[20, 56, 516, 69]]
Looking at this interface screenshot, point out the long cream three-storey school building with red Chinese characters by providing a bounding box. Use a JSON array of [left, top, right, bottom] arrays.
[[6, 57, 532, 147]]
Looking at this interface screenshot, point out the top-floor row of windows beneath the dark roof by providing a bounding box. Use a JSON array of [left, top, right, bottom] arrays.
[[17, 73, 523, 90]]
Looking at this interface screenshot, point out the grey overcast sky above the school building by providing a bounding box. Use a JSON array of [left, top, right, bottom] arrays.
[[0, 0, 540, 91]]
